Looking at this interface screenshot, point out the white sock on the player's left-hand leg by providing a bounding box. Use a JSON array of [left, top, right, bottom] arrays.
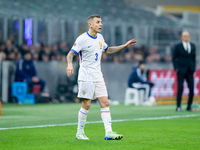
[[77, 107, 89, 134]]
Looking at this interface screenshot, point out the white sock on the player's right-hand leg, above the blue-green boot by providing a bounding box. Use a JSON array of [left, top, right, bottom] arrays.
[[101, 107, 112, 134]]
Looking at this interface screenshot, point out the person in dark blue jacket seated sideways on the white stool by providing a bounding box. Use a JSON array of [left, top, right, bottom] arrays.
[[128, 60, 154, 104]]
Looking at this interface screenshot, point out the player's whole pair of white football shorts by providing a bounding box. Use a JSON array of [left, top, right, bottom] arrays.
[[78, 81, 108, 100]]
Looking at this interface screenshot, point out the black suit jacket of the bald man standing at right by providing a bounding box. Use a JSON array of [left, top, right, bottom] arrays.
[[172, 42, 196, 74]]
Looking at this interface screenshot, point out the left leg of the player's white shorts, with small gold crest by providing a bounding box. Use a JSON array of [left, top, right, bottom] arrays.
[[78, 81, 95, 99]]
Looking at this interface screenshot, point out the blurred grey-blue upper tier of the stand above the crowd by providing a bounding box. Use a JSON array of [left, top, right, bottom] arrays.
[[0, 0, 177, 27]]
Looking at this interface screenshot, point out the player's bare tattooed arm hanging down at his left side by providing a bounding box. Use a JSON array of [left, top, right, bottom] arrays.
[[66, 51, 76, 77]]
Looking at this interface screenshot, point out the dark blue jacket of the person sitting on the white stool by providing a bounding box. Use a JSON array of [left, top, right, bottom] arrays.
[[128, 67, 149, 87]]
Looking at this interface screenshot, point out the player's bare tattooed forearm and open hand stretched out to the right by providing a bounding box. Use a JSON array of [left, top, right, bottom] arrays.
[[106, 39, 137, 54]]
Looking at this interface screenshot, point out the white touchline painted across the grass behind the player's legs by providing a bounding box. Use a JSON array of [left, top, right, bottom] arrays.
[[0, 114, 200, 130]]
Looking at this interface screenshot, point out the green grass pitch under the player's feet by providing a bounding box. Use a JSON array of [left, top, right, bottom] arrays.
[[0, 103, 200, 150]]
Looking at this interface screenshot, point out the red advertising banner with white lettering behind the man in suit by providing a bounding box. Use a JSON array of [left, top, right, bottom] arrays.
[[149, 70, 200, 104]]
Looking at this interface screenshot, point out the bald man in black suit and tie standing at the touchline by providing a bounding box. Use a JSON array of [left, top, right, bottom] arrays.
[[172, 31, 196, 111]]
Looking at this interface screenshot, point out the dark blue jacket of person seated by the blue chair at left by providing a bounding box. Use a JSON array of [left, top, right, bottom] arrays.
[[15, 57, 37, 82]]
